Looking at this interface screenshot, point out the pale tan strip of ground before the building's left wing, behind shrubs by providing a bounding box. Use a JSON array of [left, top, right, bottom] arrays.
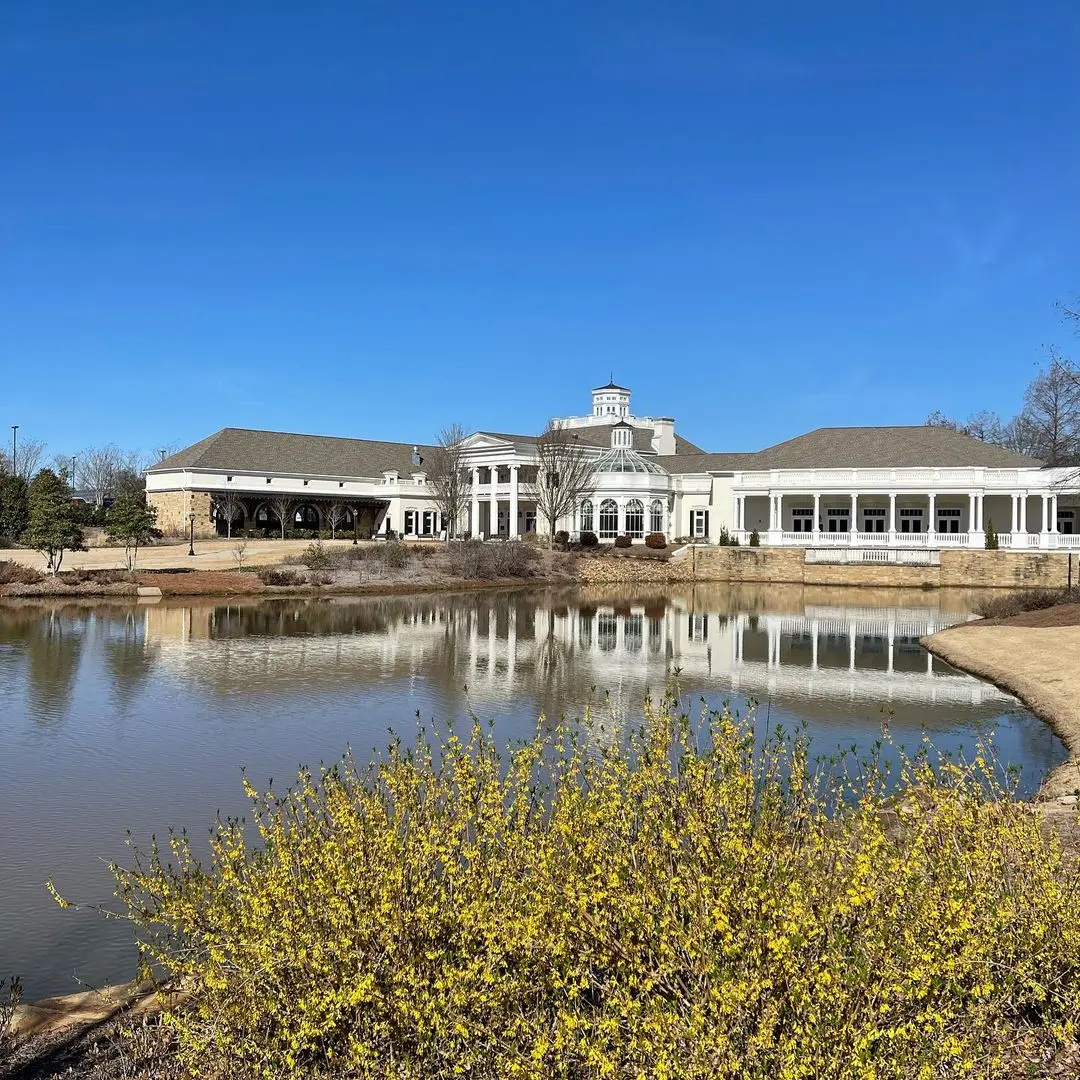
[[0, 539, 362, 570]]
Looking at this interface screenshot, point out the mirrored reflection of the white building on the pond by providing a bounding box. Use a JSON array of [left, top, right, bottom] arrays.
[[144, 592, 1015, 734]]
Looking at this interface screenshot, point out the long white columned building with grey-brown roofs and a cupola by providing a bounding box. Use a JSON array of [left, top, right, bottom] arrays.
[[147, 382, 1080, 558]]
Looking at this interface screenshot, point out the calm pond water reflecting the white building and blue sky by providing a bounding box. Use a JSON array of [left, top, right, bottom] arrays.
[[0, 586, 1065, 998]]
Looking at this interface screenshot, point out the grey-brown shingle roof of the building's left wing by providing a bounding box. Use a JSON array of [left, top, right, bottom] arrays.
[[148, 428, 435, 477]]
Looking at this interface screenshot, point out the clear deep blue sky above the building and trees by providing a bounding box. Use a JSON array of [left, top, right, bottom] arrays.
[[0, 0, 1080, 453]]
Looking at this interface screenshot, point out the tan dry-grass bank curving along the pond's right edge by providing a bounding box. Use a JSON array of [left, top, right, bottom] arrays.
[[922, 626, 1080, 805]]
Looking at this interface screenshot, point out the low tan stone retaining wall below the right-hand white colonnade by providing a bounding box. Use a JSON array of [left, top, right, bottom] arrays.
[[578, 548, 1080, 589]]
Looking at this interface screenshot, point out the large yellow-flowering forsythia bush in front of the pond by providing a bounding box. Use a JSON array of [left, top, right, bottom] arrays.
[[116, 702, 1080, 1080]]
